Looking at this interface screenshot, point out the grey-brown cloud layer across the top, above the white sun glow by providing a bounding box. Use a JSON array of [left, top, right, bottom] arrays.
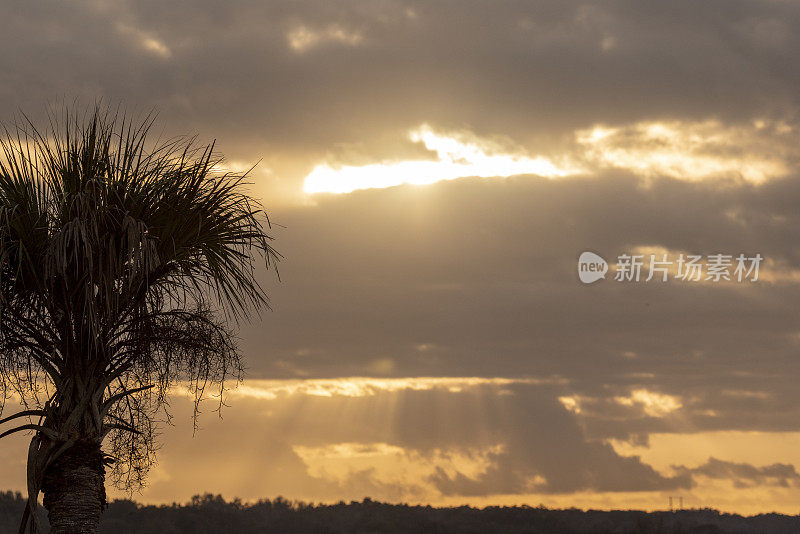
[[0, 0, 800, 201]]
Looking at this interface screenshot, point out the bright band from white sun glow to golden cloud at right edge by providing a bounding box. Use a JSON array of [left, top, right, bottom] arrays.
[[303, 120, 797, 194]]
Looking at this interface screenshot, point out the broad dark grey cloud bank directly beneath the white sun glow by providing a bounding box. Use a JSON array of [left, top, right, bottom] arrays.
[[244, 175, 800, 444]]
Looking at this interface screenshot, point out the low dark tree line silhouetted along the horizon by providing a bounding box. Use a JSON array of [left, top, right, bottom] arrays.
[[0, 491, 800, 534]]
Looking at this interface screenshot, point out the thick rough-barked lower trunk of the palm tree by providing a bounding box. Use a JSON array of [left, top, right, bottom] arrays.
[[42, 441, 106, 534]]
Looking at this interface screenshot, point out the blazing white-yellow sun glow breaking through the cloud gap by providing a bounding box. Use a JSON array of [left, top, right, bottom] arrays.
[[303, 125, 578, 194]]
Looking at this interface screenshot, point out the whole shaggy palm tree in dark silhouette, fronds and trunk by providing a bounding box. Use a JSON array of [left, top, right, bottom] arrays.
[[0, 107, 279, 533]]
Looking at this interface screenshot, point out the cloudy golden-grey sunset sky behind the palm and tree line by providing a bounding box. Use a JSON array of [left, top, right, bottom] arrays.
[[0, 0, 800, 514]]
